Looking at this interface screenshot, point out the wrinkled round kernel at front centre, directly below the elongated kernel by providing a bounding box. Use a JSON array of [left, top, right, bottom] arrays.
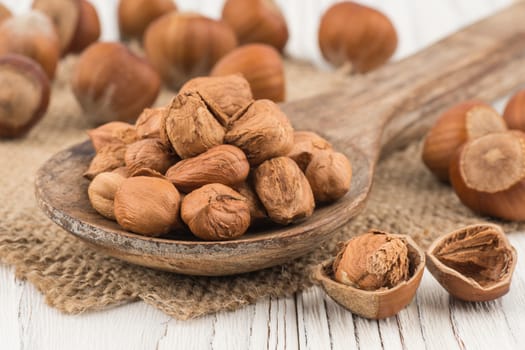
[[181, 184, 250, 241]]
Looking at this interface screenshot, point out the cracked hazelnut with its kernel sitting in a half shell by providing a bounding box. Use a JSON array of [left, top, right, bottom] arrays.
[[313, 230, 425, 319]]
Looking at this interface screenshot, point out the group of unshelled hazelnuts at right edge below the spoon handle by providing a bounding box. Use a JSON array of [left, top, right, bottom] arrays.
[[422, 90, 525, 220]]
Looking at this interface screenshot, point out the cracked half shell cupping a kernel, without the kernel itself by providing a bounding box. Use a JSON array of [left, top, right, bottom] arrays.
[[312, 230, 425, 319]]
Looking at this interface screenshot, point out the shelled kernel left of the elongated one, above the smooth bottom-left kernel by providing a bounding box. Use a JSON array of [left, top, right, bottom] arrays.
[[124, 139, 178, 174]]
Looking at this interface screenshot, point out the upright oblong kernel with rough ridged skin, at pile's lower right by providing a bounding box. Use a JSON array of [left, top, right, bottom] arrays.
[[254, 157, 315, 225]]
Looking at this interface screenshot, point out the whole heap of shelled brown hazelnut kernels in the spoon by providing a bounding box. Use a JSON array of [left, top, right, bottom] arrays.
[[84, 75, 352, 240]]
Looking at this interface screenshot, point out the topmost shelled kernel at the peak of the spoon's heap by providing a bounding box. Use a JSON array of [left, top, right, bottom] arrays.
[[179, 74, 253, 121]]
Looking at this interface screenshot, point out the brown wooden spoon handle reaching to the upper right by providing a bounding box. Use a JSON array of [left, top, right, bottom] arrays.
[[283, 2, 525, 161]]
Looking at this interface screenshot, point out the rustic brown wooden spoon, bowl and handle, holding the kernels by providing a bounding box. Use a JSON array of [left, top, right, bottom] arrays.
[[36, 3, 525, 275]]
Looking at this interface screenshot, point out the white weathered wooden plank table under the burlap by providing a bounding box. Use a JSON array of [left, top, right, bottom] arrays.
[[0, 0, 525, 350]]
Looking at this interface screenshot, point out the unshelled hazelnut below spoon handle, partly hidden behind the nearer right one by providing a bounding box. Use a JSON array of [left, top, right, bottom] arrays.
[[422, 100, 507, 181]]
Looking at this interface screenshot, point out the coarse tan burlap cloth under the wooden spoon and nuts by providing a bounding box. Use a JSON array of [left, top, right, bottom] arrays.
[[0, 57, 523, 319]]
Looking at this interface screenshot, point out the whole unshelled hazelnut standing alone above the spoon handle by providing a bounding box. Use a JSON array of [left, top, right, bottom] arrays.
[[318, 1, 397, 73]]
